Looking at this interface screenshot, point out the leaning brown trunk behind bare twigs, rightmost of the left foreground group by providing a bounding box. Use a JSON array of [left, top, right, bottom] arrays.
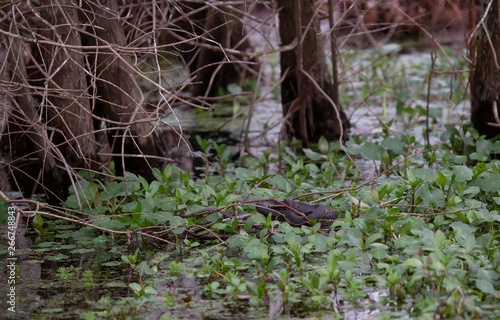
[[82, 0, 161, 179]]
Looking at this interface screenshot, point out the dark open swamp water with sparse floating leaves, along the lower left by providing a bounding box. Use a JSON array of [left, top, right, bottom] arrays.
[[0, 221, 409, 320]]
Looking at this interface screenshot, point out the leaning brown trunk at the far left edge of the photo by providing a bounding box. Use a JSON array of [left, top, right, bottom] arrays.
[[0, 19, 67, 202]]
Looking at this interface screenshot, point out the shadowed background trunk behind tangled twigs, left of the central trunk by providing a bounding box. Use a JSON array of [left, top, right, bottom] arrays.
[[166, 1, 255, 99]]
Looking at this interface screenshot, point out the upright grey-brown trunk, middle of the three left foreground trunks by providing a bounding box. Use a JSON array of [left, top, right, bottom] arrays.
[[40, 0, 96, 168]]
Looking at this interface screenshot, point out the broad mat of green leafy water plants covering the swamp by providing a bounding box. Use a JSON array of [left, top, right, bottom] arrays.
[[5, 119, 500, 319]]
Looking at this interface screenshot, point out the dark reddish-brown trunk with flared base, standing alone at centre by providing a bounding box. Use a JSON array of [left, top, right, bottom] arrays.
[[278, 0, 350, 145]]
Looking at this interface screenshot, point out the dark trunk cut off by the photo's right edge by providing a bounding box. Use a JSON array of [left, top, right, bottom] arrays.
[[471, 1, 500, 138]]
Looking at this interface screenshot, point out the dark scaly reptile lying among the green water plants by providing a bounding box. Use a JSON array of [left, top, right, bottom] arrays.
[[256, 199, 338, 226]]
